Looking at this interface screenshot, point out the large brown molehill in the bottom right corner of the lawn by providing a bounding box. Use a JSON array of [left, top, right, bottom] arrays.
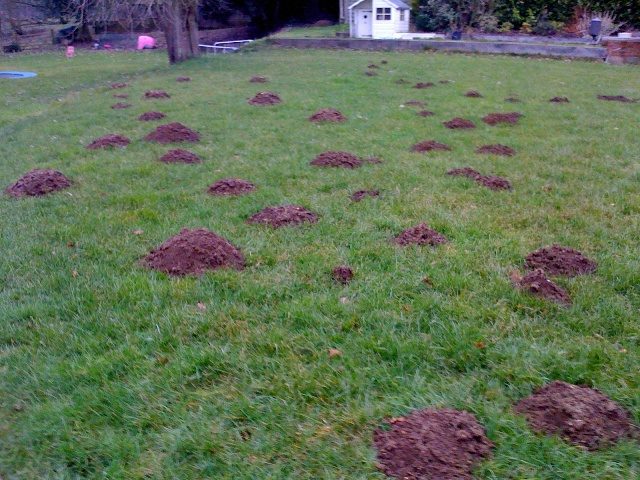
[[515, 381, 634, 450]]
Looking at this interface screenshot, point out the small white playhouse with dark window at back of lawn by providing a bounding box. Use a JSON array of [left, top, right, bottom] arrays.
[[349, 0, 411, 38]]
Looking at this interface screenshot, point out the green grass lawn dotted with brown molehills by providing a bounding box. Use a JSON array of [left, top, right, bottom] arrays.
[[0, 48, 640, 480]]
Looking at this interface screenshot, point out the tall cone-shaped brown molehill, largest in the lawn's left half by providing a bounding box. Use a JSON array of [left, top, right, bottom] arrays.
[[142, 228, 245, 276]]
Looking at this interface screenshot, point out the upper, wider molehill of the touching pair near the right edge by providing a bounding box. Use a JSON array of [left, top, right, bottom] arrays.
[[525, 245, 598, 277]]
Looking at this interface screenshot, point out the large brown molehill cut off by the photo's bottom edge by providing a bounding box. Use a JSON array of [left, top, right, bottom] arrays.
[[373, 408, 493, 480]]
